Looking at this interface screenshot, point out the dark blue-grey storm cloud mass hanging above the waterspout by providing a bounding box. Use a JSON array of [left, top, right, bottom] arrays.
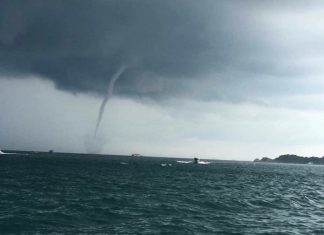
[[0, 0, 324, 98]]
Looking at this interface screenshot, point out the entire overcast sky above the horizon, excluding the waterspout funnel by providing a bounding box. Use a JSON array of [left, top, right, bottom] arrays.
[[0, 0, 324, 160]]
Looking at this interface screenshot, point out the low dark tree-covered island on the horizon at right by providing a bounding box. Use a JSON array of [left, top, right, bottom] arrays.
[[254, 154, 324, 165]]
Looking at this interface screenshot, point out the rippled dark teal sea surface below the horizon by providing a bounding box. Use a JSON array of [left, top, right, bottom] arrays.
[[0, 154, 324, 234]]
